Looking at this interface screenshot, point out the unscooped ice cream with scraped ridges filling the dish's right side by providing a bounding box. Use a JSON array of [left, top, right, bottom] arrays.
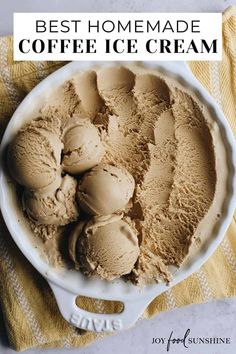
[[94, 67, 216, 285]]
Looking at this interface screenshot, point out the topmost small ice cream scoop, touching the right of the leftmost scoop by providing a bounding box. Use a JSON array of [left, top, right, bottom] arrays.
[[62, 117, 105, 174]]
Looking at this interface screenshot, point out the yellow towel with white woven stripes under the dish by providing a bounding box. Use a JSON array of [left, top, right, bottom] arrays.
[[0, 7, 236, 351]]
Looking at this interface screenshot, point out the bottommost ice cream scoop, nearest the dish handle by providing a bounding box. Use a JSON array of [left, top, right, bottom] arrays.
[[69, 215, 139, 280]]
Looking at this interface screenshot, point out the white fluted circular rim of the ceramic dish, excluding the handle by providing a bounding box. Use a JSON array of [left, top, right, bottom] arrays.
[[0, 61, 236, 300]]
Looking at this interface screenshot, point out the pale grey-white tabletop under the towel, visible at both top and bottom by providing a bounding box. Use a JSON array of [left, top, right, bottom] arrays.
[[0, 0, 236, 354]]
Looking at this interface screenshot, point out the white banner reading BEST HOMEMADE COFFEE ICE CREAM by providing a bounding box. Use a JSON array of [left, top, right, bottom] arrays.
[[14, 13, 222, 61]]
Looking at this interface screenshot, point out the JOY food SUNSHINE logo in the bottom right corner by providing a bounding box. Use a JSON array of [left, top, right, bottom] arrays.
[[152, 328, 231, 352]]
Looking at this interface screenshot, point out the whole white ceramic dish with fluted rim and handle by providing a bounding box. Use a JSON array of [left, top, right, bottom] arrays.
[[0, 62, 236, 332]]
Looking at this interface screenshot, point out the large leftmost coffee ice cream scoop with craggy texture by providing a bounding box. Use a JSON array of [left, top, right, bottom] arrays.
[[7, 121, 63, 194]]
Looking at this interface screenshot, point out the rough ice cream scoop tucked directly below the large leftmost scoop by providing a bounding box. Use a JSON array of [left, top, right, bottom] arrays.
[[22, 175, 78, 225]]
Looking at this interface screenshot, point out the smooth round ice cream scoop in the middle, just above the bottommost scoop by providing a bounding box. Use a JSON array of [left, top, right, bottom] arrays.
[[78, 164, 135, 215]]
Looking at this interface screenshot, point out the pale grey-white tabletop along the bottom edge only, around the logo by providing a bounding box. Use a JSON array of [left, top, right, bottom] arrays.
[[0, 299, 236, 354]]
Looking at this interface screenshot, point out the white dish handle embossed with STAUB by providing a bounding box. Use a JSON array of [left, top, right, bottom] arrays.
[[49, 281, 153, 333]]
